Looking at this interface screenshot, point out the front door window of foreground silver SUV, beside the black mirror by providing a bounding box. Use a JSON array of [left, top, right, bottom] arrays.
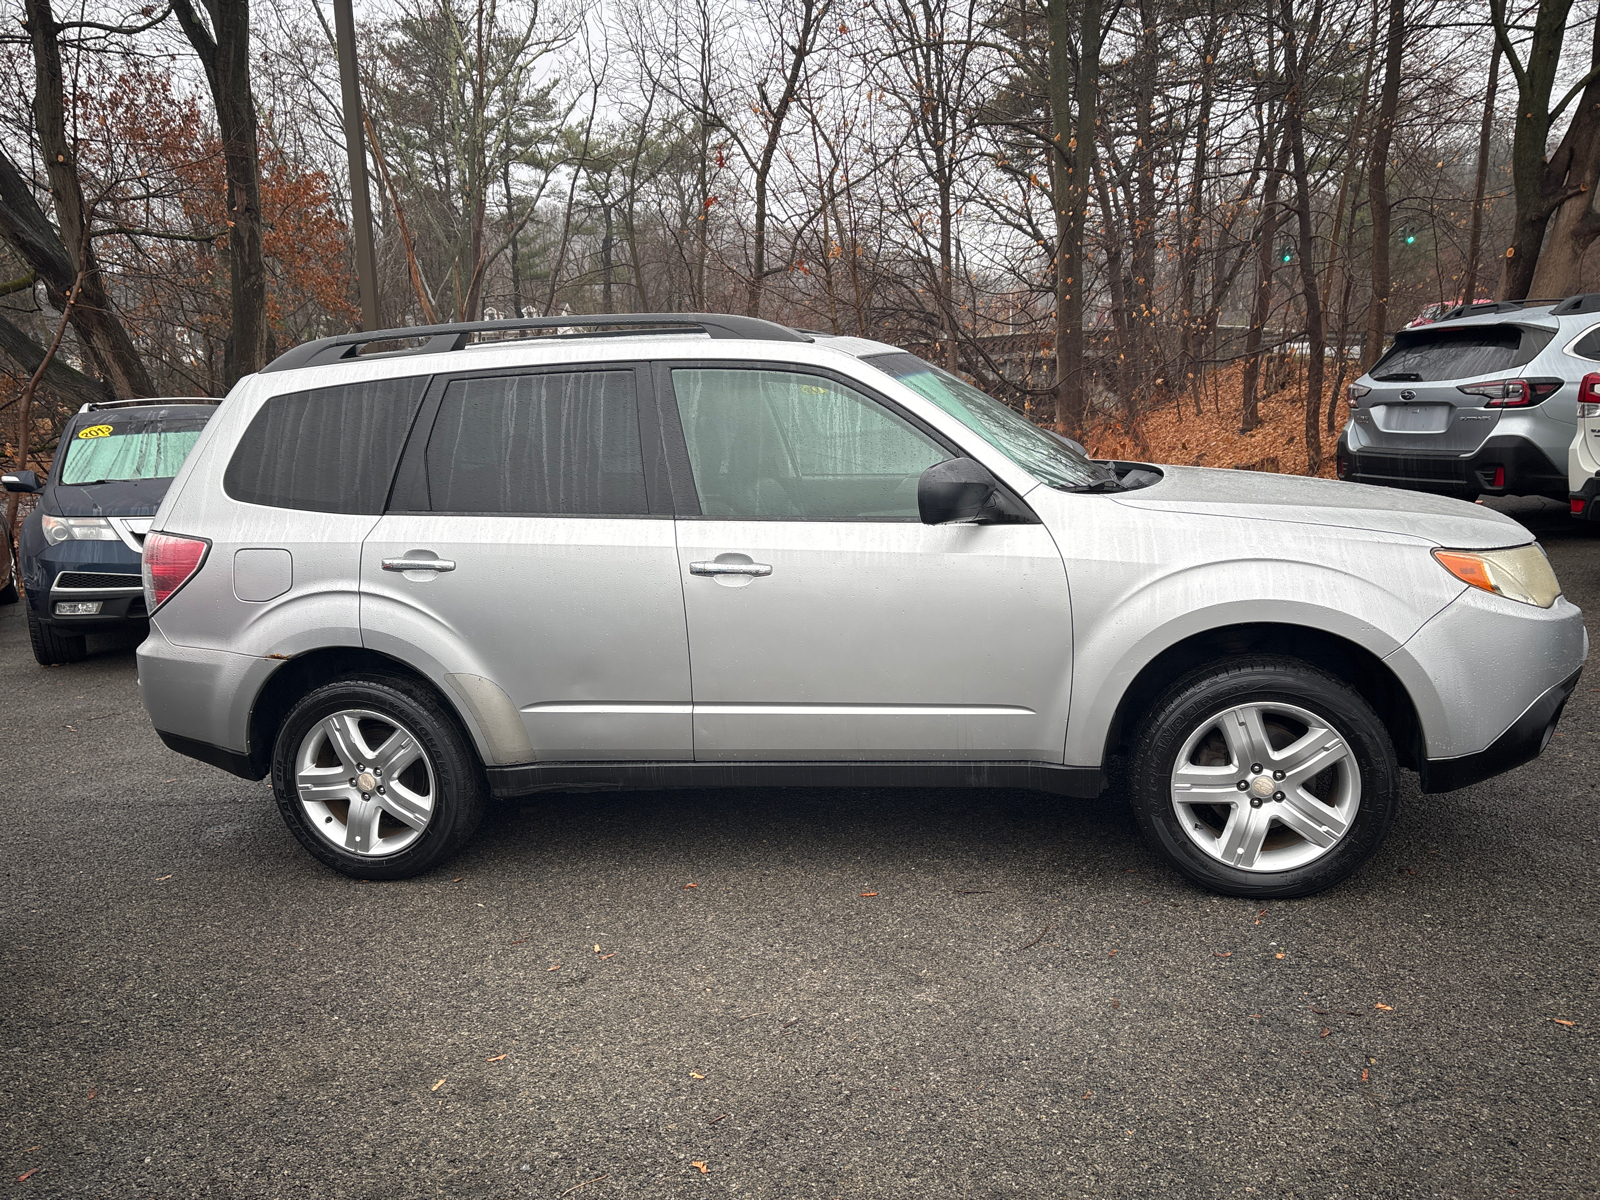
[[672, 368, 949, 520]]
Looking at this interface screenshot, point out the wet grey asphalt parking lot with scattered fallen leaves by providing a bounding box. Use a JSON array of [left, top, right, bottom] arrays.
[[0, 502, 1600, 1200]]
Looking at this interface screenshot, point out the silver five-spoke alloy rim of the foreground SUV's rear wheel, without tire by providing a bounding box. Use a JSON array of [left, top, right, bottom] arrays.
[[294, 709, 437, 858]]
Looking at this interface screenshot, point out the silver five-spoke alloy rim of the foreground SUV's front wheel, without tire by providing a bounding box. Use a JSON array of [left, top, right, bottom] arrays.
[[1173, 701, 1362, 870]]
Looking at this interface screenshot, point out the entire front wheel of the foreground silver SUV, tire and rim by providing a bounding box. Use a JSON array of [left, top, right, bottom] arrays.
[[1131, 658, 1400, 899]]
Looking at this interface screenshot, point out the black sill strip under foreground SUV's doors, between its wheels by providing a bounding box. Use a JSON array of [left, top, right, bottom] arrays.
[[480, 764, 1101, 800]]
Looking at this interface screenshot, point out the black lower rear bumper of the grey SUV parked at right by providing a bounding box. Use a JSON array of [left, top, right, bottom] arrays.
[[1338, 430, 1568, 499]]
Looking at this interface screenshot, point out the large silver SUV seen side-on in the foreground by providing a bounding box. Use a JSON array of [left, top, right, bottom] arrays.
[[139, 315, 1587, 896]]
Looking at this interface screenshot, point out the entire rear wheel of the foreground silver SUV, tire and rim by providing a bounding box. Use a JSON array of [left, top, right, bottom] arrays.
[[272, 677, 488, 880]]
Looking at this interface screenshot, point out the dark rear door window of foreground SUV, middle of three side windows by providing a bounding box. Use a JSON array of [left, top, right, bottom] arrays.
[[427, 371, 648, 517]]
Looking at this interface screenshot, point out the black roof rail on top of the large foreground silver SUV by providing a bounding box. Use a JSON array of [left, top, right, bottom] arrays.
[[261, 312, 811, 374]]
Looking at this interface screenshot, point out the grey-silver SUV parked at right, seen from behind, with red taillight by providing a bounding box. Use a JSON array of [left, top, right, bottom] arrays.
[[1338, 293, 1600, 504]]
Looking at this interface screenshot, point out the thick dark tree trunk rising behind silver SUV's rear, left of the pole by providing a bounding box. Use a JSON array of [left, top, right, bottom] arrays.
[[173, 0, 267, 387]]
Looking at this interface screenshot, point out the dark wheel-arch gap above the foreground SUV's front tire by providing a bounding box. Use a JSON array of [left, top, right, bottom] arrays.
[[1104, 621, 1426, 770]]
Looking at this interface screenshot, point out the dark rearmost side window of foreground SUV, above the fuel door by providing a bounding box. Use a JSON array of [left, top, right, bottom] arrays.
[[222, 376, 427, 514]]
